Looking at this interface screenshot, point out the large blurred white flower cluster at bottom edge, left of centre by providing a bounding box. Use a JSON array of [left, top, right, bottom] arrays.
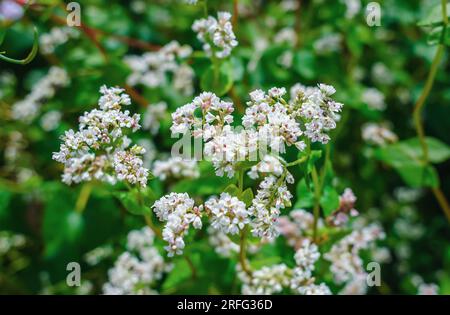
[[103, 227, 171, 295]]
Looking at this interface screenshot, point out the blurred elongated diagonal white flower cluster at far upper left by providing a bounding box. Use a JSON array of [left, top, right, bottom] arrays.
[[12, 67, 70, 123]]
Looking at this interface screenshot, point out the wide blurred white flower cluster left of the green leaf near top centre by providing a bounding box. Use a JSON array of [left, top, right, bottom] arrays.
[[124, 41, 194, 95]]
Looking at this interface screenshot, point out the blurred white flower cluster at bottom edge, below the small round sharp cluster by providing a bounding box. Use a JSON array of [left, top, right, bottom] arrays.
[[237, 264, 289, 295]]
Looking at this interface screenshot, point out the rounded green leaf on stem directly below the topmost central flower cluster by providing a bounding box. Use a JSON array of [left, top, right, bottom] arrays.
[[200, 62, 234, 96]]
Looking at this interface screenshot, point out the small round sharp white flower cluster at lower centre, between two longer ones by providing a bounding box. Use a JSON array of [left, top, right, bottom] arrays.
[[205, 193, 250, 234]]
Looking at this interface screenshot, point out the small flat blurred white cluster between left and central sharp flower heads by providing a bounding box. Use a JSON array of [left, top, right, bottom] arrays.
[[153, 156, 200, 180]]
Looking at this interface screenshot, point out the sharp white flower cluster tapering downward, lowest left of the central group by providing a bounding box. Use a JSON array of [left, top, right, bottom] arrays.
[[152, 193, 203, 257]]
